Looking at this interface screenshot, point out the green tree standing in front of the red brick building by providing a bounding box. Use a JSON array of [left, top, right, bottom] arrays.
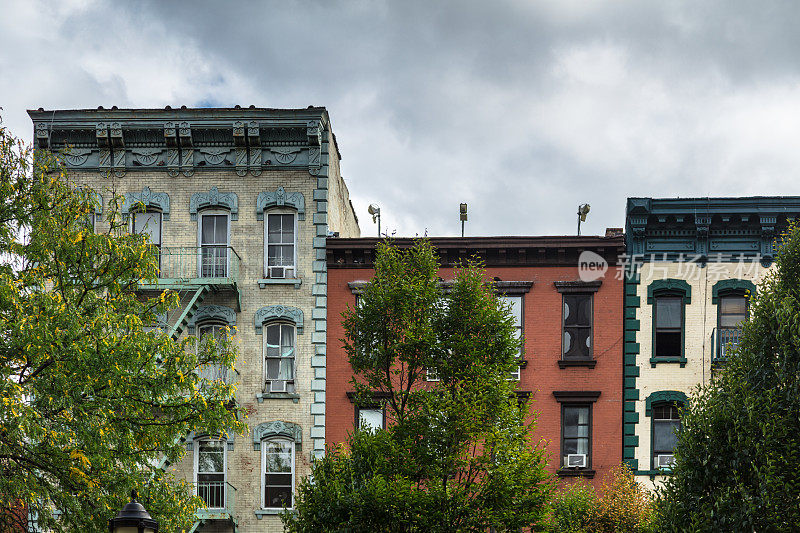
[[284, 240, 551, 532]]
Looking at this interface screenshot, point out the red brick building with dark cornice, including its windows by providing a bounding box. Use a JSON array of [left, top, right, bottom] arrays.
[[325, 236, 624, 484]]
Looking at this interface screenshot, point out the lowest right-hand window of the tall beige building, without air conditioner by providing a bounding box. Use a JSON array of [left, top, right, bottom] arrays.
[[261, 439, 294, 509]]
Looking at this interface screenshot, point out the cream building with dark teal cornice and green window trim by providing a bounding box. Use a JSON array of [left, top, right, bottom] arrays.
[[624, 197, 800, 487]]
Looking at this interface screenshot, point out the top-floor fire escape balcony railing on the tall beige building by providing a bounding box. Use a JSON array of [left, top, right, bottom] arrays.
[[143, 246, 242, 285]]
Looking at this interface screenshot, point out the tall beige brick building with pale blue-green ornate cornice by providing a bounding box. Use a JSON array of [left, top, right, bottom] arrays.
[[29, 107, 359, 532]]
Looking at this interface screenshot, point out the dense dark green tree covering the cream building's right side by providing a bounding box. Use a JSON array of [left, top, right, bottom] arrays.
[[659, 221, 800, 531]]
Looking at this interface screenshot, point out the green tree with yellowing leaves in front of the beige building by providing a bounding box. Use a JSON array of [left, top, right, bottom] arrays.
[[0, 124, 244, 531]]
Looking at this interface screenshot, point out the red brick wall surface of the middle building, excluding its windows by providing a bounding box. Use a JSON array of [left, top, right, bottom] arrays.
[[326, 237, 623, 486]]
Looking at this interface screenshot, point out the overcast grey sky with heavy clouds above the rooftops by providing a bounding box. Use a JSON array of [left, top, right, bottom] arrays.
[[0, 0, 800, 236]]
